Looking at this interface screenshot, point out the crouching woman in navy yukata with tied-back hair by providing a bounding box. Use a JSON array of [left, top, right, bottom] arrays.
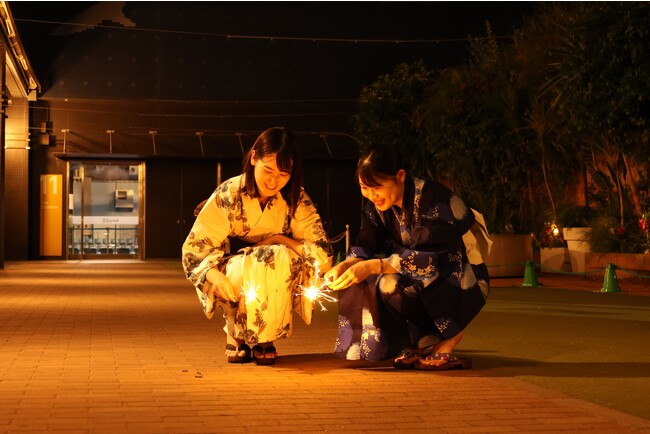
[[325, 146, 489, 370]]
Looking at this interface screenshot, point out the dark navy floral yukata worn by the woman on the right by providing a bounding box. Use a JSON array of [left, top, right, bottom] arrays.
[[336, 177, 489, 360]]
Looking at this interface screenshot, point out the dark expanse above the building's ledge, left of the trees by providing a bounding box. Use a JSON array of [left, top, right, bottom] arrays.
[[9, 1, 535, 101]]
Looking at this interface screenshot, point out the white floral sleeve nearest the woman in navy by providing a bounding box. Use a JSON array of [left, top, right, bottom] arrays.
[[291, 190, 332, 271]]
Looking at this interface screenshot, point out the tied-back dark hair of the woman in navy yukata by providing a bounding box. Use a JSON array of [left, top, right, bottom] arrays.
[[355, 145, 405, 187]]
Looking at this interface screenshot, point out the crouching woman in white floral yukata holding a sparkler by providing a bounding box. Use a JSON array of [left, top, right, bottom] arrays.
[[183, 127, 332, 365]]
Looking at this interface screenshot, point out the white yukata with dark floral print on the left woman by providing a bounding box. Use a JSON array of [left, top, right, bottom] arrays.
[[183, 175, 332, 344]]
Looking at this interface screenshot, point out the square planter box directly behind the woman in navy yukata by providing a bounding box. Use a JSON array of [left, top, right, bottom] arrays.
[[485, 234, 533, 277]]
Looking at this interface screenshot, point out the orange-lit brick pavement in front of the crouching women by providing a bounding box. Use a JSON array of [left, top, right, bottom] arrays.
[[0, 261, 650, 433]]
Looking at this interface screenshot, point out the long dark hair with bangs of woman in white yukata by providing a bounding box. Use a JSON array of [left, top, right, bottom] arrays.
[[242, 127, 302, 215]]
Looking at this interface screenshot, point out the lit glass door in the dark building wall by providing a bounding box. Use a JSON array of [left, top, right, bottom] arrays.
[[67, 162, 142, 259]]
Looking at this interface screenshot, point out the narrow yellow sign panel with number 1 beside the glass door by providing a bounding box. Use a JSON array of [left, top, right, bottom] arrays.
[[41, 175, 63, 256]]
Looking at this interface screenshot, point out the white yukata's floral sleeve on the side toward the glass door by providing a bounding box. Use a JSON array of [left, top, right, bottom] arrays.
[[182, 188, 235, 291]]
